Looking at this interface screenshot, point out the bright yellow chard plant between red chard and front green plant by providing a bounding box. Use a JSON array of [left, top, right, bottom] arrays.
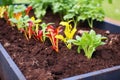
[[56, 21, 77, 49]]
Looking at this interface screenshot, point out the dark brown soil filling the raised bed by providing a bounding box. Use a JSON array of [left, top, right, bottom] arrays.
[[0, 12, 120, 80]]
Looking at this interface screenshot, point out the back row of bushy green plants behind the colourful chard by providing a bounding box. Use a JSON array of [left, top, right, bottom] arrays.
[[30, 0, 115, 28]]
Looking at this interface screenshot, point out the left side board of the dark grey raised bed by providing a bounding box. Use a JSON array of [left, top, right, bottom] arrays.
[[0, 44, 26, 80]]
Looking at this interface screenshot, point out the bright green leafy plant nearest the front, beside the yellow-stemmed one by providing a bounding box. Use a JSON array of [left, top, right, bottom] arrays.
[[68, 30, 106, 59]]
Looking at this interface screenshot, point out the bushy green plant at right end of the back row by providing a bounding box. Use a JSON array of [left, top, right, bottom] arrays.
[[84, 0, 105, 28]]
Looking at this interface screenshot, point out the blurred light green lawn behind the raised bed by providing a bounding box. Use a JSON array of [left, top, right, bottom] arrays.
[[14, 0, 120, 21]]
